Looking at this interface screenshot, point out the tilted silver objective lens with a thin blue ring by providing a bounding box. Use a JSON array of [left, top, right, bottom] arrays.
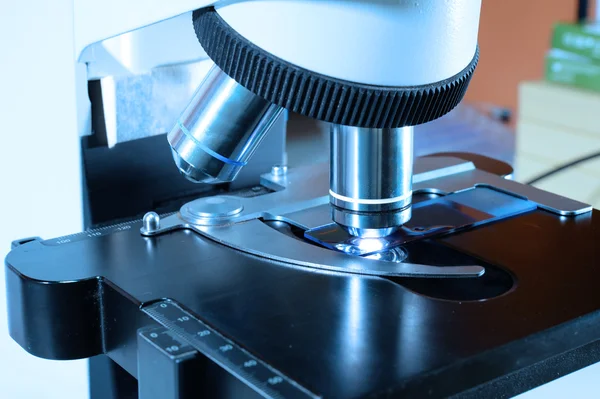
[[167, 66, 283, 184]]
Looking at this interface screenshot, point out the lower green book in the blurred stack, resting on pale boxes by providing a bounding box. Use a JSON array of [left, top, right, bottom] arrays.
[[545, 49, 600, 91]]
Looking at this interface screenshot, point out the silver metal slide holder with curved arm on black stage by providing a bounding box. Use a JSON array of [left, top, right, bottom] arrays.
[[141, 157, 592, 278]]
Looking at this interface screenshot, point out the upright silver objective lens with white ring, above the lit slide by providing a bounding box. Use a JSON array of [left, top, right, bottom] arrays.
[[329, 125, 413, 237]]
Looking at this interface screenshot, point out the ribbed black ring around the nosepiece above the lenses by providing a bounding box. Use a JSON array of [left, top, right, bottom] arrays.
[[193, 8, 479, 128]]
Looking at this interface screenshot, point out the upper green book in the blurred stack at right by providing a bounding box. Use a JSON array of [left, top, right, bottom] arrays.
[[552, 23, 600, 62]]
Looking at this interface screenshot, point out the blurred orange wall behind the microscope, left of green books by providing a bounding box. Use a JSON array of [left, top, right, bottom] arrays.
[[466, 0, 592, 109]]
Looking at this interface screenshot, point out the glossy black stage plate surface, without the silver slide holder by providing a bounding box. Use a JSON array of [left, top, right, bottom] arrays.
[[6, 193, 600, 399]]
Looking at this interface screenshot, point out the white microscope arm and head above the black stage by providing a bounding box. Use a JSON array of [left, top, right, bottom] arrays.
[[7, 0, 481, 238]]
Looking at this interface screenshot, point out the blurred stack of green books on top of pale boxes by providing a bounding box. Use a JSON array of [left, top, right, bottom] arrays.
[[545, 23, 600, 91]]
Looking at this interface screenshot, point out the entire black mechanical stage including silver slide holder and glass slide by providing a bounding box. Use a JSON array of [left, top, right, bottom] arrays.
[[6, 158, 600, 399]]
